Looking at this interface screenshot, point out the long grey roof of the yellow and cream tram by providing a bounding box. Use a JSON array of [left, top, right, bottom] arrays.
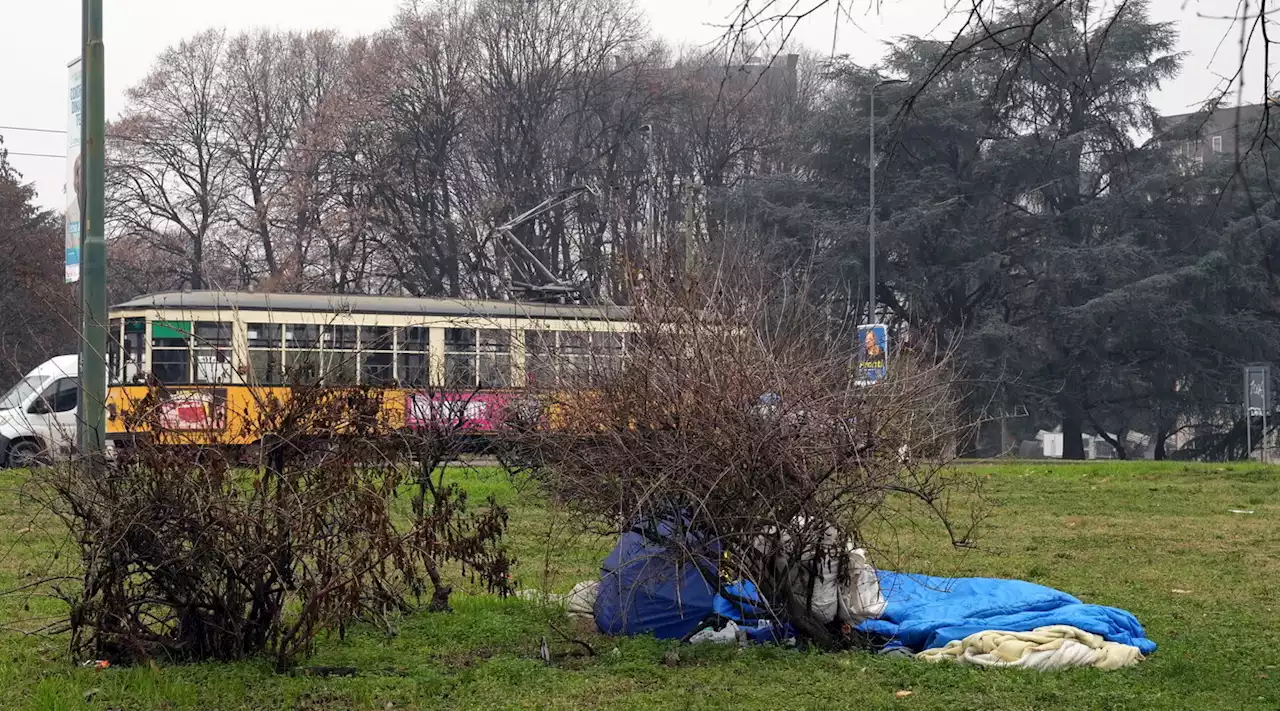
[[113, 291, 630, 320]]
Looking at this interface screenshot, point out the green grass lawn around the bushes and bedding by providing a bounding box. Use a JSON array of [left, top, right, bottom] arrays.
[[0, 462, 1280, 711]]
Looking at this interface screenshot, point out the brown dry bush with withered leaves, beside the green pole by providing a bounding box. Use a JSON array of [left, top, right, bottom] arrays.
[[31, 384, 512, 669]]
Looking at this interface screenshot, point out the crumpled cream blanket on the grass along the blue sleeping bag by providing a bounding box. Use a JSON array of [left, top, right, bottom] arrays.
[[916, 625, 1142, 671]]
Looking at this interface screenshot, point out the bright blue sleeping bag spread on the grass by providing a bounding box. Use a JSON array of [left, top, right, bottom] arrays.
[[858, 570, 1156, 655]]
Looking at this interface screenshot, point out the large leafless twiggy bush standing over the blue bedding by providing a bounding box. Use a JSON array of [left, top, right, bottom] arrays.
[[503, 275, 977, 644]]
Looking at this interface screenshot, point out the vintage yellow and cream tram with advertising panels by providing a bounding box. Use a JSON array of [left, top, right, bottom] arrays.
[[108, 291, 634, 447]]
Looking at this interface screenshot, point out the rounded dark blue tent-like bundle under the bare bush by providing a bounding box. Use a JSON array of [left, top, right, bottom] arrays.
[[595, 520, 718, 639]]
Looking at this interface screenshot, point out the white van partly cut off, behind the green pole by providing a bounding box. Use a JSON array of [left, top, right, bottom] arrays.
[[0, 355, 79, 469]]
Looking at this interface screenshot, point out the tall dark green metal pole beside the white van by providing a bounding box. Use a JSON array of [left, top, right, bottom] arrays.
[[79, 0, 106, 473]]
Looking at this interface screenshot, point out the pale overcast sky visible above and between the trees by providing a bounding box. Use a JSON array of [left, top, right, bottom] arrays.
[[0, 0, 1262, 208]]
